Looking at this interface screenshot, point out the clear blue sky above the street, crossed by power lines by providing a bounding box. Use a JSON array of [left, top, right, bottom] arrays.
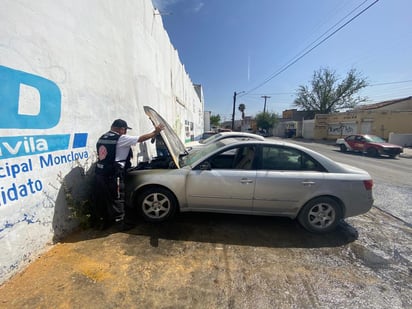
[[152, 0, 412, 121]]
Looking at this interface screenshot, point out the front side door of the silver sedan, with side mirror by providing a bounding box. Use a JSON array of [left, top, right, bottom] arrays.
[[186, 147, 256, 213]]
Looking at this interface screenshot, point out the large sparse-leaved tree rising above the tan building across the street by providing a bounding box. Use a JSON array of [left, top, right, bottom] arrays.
[[294, 68, 368, 114]]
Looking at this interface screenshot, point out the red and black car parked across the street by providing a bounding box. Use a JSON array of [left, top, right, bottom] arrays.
[[336, 134, 403, 158]]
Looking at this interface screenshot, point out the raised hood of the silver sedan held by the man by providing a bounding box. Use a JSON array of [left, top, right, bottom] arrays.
[[143, 106, 186, 168]]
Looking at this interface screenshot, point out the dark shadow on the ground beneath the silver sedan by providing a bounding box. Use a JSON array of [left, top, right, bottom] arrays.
[[62, 213, 358, 248]]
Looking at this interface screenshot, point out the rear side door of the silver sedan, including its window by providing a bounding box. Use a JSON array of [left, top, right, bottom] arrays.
[[253, 145, 325, 216]]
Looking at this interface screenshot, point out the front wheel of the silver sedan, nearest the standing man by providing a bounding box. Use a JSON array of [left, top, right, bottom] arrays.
[[135, 187, 177, 222]]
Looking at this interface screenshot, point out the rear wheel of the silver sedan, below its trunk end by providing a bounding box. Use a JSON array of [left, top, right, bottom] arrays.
[[298, 197, 343, 233]]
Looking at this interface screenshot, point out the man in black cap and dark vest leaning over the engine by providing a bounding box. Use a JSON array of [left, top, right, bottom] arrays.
[[91, 119, 164, 229]]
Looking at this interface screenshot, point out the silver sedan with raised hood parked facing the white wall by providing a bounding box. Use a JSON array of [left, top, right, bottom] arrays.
[[126, 107, 373, 233]]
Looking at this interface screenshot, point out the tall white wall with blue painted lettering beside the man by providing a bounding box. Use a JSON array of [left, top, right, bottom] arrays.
[[0, 0, 203, 283]]
